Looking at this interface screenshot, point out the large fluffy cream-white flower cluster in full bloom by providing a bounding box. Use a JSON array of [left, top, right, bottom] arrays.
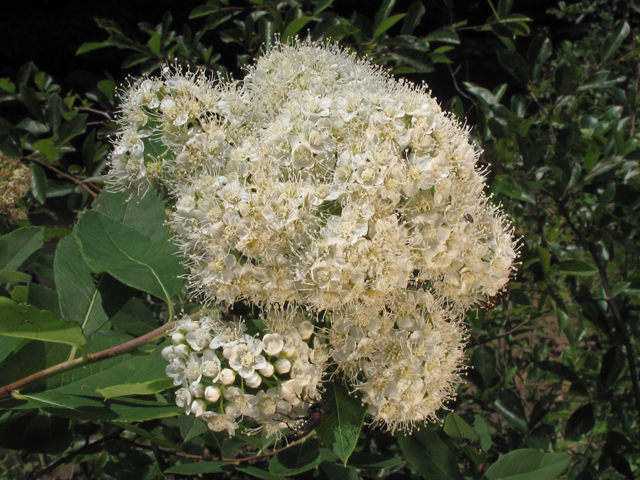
[[111, 42, 516, 430]]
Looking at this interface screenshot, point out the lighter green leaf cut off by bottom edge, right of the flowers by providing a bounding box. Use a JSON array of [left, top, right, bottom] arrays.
[[486, 449, 571, 480]]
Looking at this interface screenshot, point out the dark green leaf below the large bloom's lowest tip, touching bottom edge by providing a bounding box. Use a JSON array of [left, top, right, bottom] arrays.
[[396, 428, 462, 480]]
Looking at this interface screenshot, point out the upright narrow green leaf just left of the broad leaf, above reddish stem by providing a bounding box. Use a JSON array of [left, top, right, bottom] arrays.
[[53, 236, 109, 337]]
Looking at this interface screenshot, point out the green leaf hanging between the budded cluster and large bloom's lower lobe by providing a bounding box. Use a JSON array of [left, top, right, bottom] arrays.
[[316, 381, 366, 464]]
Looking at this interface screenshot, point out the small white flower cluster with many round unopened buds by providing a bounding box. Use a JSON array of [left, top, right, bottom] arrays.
[[162, 314, 328, 436]]
